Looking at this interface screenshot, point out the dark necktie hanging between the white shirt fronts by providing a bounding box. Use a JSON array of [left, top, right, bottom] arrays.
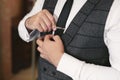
[[55, 0, 73, 36]]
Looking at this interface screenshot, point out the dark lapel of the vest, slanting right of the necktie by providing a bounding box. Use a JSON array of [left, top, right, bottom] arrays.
[[62, 0, 100, 46]]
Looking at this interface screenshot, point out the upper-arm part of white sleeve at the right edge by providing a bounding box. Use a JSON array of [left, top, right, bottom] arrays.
[[104, 0, 120, 71]]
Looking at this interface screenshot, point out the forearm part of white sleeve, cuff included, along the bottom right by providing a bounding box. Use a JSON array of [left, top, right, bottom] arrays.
[[57, 53, 120, 80]]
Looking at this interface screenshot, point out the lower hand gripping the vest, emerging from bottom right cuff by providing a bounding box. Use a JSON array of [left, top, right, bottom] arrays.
[[36, 35, 64, 67]]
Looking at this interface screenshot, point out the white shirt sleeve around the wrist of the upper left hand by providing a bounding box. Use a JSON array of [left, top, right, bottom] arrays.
[[18, 0, 44, 42]]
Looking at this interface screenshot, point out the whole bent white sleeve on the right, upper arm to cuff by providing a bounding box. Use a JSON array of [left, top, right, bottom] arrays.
[[57, 0, 120, 80]]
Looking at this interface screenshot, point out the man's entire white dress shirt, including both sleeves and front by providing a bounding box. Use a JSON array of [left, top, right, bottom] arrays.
[[18, 0, 120, 80]]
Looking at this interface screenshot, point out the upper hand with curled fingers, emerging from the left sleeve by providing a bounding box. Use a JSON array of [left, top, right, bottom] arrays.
[[25, 9, 56, 32]]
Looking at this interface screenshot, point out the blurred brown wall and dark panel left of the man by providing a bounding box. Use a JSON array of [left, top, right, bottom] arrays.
[[0, 0, 34, 80]]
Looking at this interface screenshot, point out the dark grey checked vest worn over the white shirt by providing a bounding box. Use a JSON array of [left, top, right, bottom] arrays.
[[38, 0, 113, 80]]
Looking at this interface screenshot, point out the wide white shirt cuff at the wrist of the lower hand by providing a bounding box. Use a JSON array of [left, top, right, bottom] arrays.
[[57, 53, 84, 80]]
